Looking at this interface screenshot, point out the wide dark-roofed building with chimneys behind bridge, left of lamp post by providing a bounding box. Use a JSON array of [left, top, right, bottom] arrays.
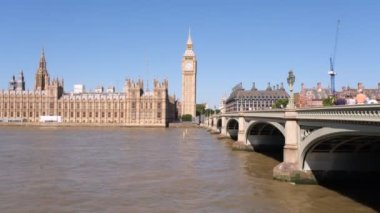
[[224, 83, 289, 112]]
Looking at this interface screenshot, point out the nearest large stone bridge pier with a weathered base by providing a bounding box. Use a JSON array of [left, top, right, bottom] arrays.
[[273, 109, 317, 184]]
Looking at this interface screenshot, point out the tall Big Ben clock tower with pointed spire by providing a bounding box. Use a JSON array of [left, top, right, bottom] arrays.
[[181, 32, 197, 118]]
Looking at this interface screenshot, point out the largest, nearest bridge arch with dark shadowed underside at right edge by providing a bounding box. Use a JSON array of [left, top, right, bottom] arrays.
[[300, 127, 380, 180]]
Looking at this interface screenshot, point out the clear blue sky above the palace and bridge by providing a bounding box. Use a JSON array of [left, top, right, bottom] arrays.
[[0, 0, 380, 106]]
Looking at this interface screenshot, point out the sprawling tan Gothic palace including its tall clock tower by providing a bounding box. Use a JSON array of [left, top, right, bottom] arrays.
[[0, 35, 196, 126]]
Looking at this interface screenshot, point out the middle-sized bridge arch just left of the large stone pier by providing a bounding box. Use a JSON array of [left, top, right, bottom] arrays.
[[245, 120, 285, 151]]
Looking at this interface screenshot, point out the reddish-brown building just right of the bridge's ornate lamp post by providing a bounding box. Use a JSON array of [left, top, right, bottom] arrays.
[[295, 82, 331, 108]]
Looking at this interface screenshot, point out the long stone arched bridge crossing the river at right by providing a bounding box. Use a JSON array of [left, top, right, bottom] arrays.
[[204, 105, 380, 183]]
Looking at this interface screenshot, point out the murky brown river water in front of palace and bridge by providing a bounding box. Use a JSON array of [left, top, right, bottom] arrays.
[[0, 127, 380, 212]]
